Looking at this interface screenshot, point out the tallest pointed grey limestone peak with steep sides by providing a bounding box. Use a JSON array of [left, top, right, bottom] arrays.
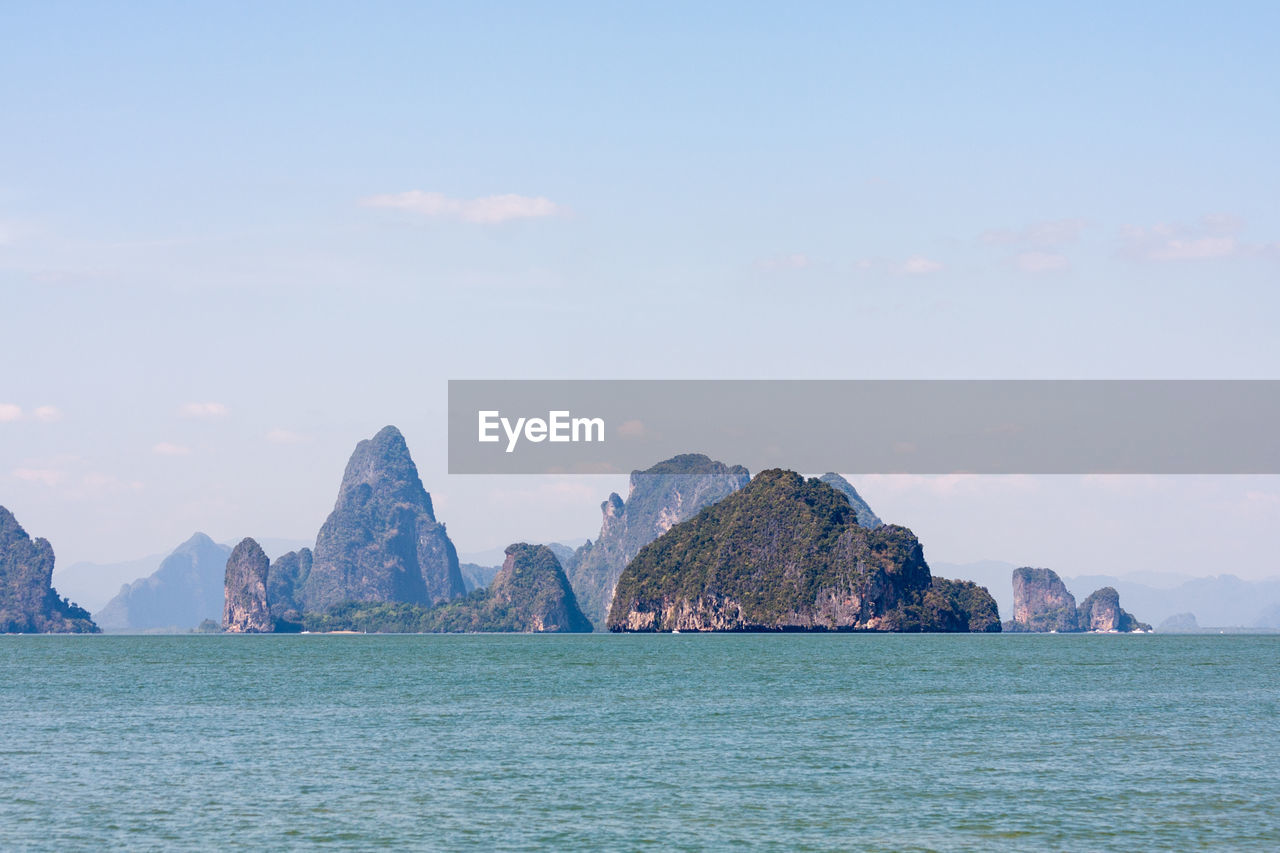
[[296, 427, 465, 611]]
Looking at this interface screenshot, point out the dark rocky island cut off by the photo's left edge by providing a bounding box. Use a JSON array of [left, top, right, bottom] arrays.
[[0, 506, 99, 634]]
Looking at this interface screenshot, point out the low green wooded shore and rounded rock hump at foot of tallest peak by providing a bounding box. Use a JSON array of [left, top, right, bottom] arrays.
[[303, 543, 591, 634]]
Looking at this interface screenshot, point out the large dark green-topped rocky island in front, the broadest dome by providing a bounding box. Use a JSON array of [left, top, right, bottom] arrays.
[[608, 469, 1000, 631]]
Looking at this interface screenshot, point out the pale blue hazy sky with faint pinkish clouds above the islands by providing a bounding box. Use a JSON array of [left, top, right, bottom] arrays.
[[0, 3, 1280, 576]]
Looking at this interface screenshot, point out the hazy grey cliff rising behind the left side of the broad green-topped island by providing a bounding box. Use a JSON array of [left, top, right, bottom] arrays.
[[567, 453, 750, 625]]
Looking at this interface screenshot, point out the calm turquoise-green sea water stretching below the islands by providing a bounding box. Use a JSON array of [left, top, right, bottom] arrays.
[[0, 634, 1280, 850]]
